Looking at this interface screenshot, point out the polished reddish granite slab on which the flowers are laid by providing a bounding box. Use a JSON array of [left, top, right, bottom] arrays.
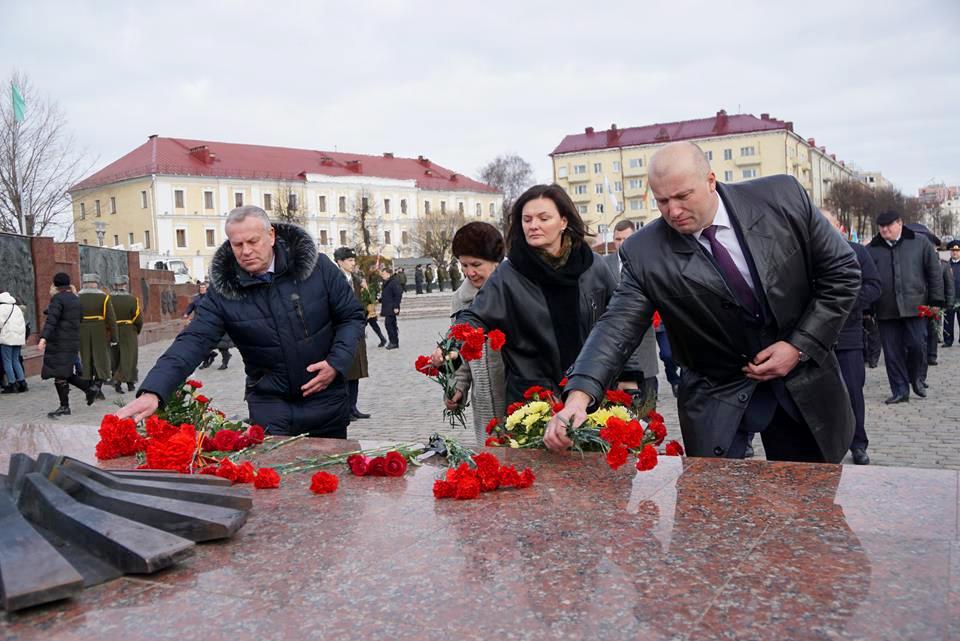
[[0, 425, 960, 641]]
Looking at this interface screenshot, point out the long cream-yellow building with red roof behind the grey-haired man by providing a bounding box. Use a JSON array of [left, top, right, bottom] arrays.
[[69, 135, 503, 278]]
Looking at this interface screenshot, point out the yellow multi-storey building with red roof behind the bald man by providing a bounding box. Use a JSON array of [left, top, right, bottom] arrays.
[[550, 111, 857, 231]]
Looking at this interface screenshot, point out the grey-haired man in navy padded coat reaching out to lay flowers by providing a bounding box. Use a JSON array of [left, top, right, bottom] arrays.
[[117, 206, 364, 438]]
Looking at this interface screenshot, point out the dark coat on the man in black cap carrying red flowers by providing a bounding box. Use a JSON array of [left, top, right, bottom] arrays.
[[868, 227, 945, 320]]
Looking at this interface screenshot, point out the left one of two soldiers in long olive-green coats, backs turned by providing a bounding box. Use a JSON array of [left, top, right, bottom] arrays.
[[77, 274, 117, 399]]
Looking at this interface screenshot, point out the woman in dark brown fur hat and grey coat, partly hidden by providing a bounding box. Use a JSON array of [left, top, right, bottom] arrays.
[[444, 222, 506, 443]]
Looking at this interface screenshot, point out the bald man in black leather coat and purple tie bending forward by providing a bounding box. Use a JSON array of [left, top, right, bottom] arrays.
[[544, 142, 860, 462]]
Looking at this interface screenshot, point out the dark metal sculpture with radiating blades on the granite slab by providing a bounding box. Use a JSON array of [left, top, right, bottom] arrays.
[[0, 454, 253, 612]]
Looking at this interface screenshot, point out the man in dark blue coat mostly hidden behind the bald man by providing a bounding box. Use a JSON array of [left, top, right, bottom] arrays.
[[820, 209, 880, 465]]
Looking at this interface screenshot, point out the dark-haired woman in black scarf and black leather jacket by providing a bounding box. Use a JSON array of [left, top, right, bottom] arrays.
[[457, 185, 635, 404]]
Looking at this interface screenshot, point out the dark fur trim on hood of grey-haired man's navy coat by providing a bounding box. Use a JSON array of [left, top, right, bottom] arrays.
[[210, 223, 317, 300]]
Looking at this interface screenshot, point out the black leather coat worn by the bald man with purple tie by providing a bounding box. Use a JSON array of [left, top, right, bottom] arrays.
[[568, 176, 860, 462]]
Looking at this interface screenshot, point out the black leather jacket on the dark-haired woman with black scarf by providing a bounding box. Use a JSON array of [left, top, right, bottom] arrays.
[[457, 254, 619, 405]]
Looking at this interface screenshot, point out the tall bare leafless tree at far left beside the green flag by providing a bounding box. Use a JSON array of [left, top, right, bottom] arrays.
[[0, 72, 92, 236]]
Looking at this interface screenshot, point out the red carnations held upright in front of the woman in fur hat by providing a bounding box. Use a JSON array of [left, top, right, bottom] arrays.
[[414, 323, 507, 427]]
